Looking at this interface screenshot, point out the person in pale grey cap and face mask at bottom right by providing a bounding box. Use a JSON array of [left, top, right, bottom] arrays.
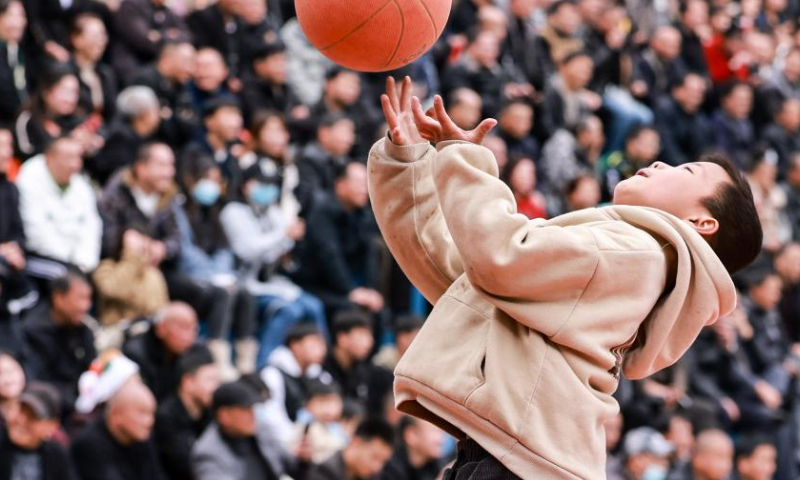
[[622, 427, 674, 480]]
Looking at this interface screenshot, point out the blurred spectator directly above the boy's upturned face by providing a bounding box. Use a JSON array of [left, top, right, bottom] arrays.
[[599, 125, 661, 201]]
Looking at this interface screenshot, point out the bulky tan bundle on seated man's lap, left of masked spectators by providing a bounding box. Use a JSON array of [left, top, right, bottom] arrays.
[[92, 229, 169, 330]]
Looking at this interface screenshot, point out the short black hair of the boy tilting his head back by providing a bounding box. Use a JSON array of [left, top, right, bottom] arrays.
[[698, 153, 764, 274]]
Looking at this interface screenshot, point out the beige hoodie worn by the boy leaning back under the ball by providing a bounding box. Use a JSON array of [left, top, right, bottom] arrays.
[[369, 140, 736, 480]]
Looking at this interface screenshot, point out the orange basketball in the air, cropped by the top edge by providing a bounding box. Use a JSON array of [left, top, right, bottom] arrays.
[[295, 0, 452, 72]]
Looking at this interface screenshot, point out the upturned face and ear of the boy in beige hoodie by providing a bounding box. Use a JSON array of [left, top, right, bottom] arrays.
[[614, 162, 730, 235]]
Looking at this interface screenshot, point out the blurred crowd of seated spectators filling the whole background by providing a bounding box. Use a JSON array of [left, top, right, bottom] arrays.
[[0, 0, 800, 480]]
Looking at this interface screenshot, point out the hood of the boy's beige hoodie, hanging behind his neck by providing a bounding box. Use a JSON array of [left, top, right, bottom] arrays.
[[602, 206, 736, 380]]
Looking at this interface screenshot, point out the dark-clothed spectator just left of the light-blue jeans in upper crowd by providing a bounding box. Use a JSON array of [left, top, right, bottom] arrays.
[[536, 52, 602, 141]]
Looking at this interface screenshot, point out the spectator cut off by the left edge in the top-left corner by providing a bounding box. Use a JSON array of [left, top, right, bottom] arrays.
[[0, 0, 29, 122]]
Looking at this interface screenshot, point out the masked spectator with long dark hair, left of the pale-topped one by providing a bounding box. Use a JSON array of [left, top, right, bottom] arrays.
[[176, 155, 258, 376]]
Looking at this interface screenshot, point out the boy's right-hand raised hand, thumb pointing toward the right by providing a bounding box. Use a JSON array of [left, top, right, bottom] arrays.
[[412, 95, 497, 145]]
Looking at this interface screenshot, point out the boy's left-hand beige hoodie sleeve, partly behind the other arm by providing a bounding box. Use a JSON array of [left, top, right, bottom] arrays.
[[368, 139, 463, 303]]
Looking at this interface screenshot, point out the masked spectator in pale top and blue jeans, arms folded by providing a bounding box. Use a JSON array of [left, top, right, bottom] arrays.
[[220, 163, 328, 366]]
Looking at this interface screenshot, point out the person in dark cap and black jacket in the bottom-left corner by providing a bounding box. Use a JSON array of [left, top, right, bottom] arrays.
[[0, 382, 78, 480]]
